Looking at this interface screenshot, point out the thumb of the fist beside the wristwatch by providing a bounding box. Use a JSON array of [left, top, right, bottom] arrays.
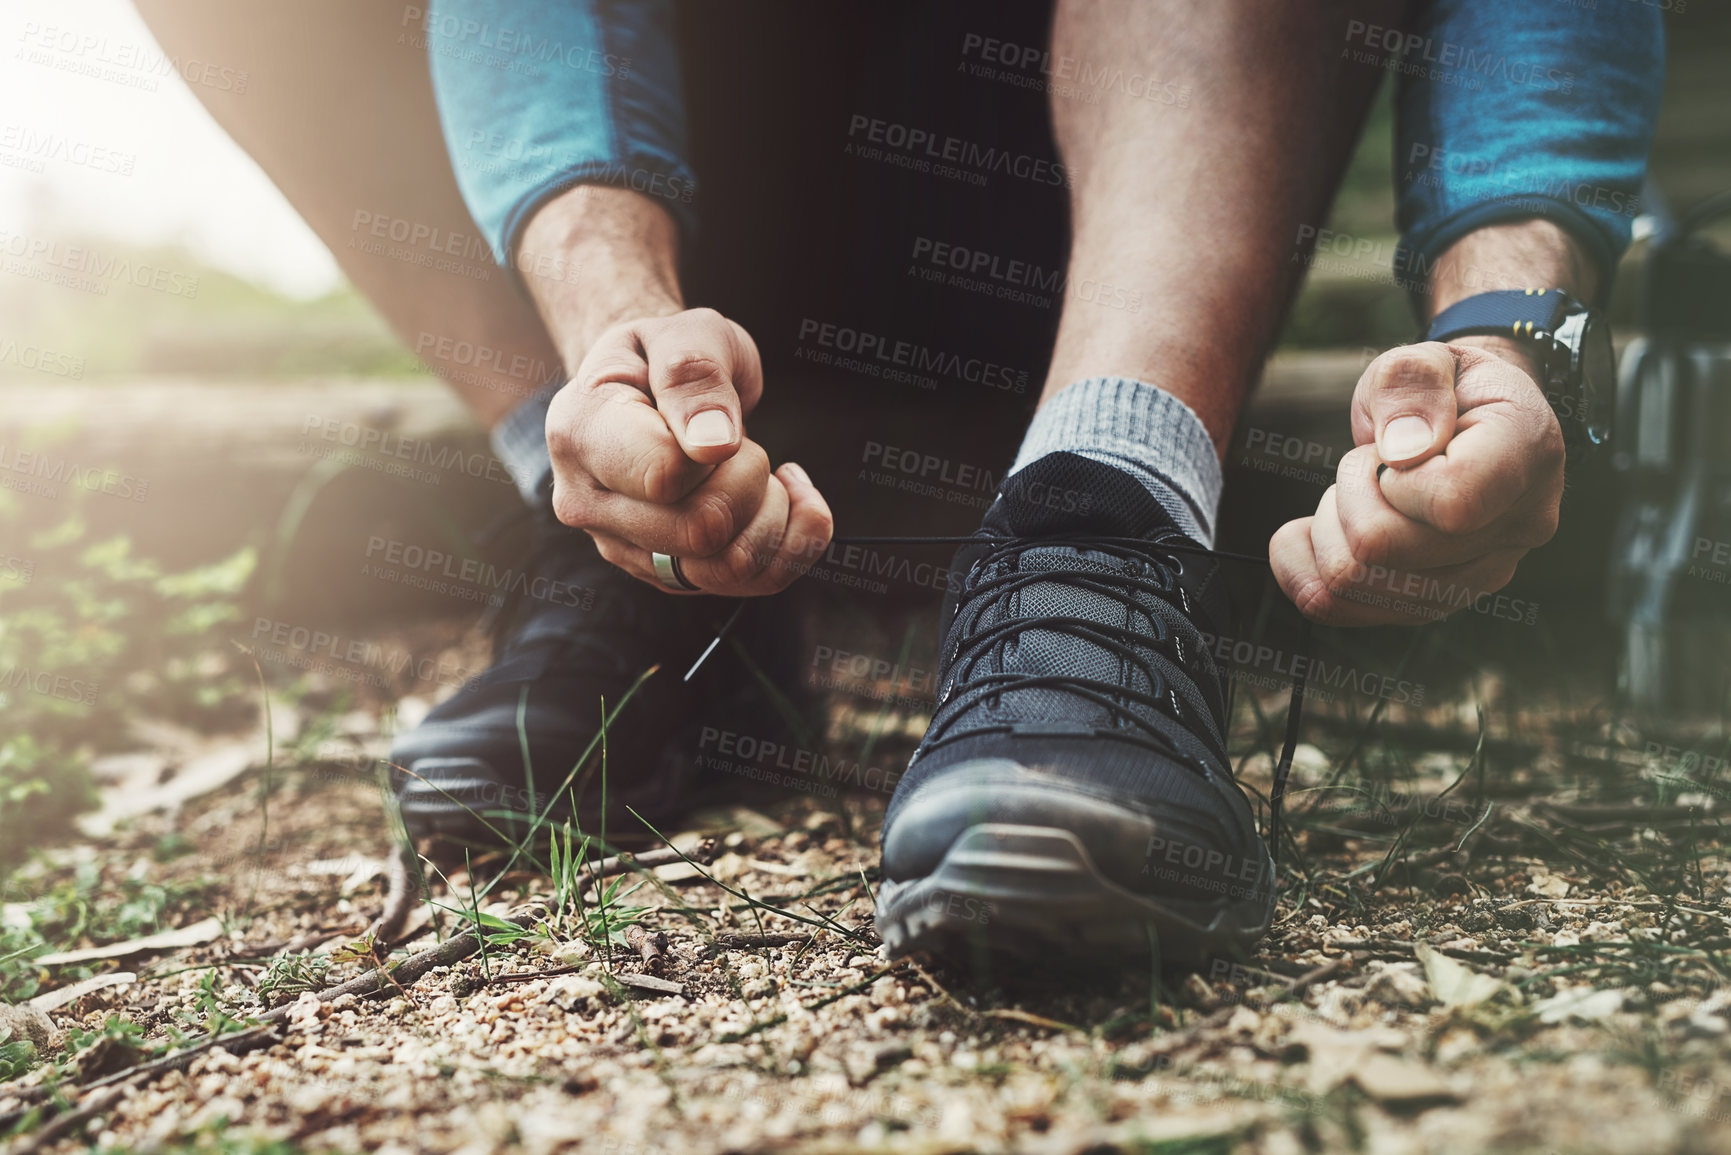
[[1352, 341, 1458, 466]]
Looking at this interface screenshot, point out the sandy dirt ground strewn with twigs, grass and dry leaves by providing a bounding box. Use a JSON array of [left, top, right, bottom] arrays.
[[0, 612, 1731, 1155]]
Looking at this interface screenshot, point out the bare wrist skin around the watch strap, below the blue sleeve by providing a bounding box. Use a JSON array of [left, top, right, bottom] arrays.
[[1426, 220, 1599, 377]]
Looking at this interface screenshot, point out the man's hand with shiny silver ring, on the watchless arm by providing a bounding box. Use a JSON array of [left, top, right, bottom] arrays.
[[547, 308, 834, 597]]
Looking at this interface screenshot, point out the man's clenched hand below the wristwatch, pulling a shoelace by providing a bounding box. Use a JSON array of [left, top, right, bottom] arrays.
[[1269, 338, 1563, 625]]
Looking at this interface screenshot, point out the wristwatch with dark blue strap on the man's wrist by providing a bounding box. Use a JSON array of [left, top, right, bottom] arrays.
[[1425, 289, 1617, 459]]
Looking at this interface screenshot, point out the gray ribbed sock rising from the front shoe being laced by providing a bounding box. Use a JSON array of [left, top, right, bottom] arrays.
[[1011, 377, 1222, 547]]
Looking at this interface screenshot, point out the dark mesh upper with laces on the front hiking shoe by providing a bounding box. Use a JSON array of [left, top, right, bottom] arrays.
[[885, 454, 1265, 897]]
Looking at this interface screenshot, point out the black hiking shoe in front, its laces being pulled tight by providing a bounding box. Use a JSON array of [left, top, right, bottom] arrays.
[[878, 454, 1274, 968]]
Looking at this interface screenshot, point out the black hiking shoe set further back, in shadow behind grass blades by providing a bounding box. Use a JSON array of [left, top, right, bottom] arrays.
[[391, 509, 761, 847]]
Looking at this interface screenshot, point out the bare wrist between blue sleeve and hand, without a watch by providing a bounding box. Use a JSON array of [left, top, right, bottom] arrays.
[[518, 185, 685, 372]]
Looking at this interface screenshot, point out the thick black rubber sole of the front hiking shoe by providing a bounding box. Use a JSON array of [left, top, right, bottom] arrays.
[[876, 823, 1274, 970]]
